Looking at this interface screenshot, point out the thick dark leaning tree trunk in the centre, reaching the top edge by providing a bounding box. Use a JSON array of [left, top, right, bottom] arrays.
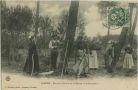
[[61, 1, 79, 76]]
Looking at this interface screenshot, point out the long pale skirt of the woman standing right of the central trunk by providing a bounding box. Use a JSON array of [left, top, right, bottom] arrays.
[[89, 50, 99, 69]]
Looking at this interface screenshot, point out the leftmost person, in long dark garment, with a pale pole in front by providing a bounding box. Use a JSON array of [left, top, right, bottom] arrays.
[[24, 36, 39, 75]]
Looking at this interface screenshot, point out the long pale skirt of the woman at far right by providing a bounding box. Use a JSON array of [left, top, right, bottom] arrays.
[[123, 53, 134, 69]]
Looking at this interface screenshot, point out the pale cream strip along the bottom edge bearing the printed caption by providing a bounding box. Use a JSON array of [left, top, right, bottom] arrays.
[[2, 72, 138, 90]]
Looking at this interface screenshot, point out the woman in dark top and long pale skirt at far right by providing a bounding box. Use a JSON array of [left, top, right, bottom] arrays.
[[123, 44, 134, 69]]
